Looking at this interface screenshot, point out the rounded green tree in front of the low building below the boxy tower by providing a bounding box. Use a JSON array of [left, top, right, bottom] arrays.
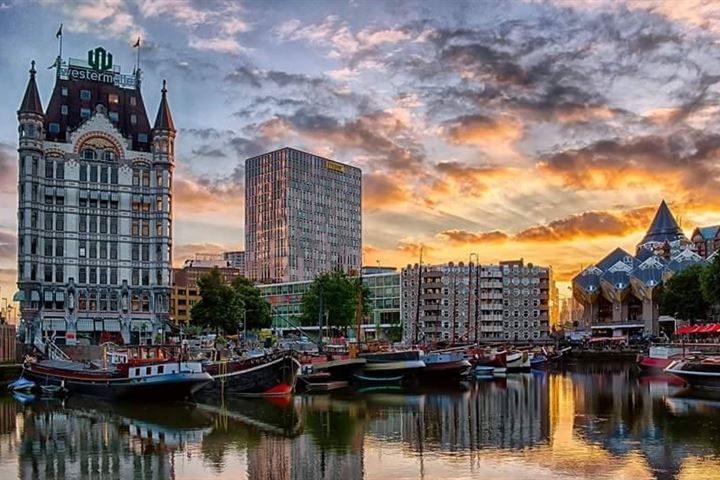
[[300, 270, 372, 327]]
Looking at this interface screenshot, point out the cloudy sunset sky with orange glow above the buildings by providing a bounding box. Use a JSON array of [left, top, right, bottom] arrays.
[[0, 0, 720, 297]]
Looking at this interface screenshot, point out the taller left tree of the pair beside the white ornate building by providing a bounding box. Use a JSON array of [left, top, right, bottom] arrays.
[[190, 267, 242, 333]]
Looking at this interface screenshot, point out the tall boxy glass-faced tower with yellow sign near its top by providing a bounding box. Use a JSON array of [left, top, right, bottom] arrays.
[[245, 148, 362, 283]]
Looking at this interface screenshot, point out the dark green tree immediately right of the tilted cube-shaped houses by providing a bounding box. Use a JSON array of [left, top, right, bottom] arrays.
[[660, 265, 708, 322]]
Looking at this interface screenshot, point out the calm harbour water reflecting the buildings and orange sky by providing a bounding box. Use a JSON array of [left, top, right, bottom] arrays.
[[0, 364, 720, 480]]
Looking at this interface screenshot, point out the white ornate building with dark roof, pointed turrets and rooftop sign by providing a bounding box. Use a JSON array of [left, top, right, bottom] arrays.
[[15, 47, 176, 344]]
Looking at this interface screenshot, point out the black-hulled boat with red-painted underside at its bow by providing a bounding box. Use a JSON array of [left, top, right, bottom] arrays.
[[197, 351, 300, 400]]
